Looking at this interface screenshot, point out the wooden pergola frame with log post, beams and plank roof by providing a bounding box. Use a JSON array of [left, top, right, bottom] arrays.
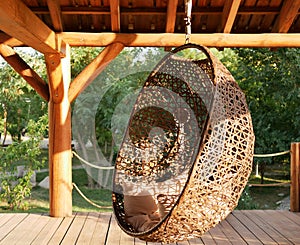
[[0, 0, 300, 217]]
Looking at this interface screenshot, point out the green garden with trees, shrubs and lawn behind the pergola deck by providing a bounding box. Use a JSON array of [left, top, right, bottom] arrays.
[[0, 48, 300, 212]]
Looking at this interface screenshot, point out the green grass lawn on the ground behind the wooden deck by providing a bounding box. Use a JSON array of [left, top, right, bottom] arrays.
[[0, 147, 290, 213]]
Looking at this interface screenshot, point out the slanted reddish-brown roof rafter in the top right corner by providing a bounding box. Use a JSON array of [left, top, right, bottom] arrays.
[[272, 0, 300, 33]]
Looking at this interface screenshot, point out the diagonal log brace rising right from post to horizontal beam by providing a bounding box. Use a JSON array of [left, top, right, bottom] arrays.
[[69, 43, 124, 103]]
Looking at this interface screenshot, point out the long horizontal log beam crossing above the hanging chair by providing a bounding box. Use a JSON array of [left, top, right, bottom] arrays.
[[57, 32, 300, 48]]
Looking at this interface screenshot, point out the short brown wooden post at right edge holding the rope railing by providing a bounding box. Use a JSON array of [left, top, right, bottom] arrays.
[[290, 142, 300, 212]]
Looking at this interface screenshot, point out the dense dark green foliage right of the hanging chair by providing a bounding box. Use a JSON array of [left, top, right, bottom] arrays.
[[222, 48, 300, 153]]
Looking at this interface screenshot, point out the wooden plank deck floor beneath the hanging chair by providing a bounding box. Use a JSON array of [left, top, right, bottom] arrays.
[[0, 210, 300, 245]]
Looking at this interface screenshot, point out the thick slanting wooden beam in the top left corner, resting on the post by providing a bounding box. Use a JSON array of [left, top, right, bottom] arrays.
[[0, 0, 59, 53]]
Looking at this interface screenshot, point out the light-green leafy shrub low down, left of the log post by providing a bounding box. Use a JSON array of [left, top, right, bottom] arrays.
[[0, 116, 48, 210]]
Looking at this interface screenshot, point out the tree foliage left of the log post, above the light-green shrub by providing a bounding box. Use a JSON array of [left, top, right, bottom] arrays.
[[0, 48, 47, 143]]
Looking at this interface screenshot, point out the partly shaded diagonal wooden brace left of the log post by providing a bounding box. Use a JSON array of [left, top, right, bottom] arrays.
[[0, 44, 49, 101]]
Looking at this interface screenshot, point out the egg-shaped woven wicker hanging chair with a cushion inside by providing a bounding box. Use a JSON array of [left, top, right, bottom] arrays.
[[113, 44, 254, 243]]
